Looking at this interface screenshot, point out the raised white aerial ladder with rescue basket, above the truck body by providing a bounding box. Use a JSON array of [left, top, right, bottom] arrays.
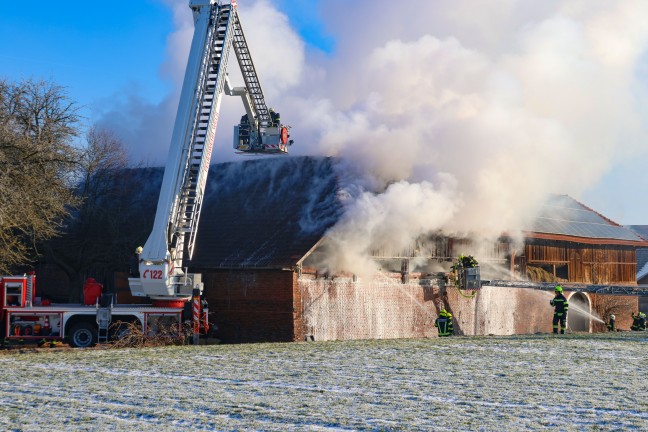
[[129, 0, 292, 307]]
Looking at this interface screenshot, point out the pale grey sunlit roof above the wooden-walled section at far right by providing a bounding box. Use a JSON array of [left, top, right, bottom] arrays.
[[529, 195, 644, 242]]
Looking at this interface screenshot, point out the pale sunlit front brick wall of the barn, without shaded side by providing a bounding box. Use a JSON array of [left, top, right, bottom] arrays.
[[298, 276, 636, 340]]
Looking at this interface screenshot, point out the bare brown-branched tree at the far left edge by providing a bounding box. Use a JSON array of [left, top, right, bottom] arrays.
[[0, 80, 79, 273]]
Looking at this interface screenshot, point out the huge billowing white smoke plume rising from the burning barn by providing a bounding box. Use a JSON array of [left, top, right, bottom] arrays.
[[98, 0, 648, 273]]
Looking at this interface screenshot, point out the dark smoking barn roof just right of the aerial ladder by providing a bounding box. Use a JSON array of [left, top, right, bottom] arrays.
[[190, 156, 342, 269]]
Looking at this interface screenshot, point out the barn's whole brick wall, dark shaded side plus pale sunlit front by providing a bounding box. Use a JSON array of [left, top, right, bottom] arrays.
[[203, 270, 638, 343]]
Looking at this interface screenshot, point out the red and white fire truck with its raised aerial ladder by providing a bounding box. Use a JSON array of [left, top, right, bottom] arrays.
[[0, 0, 292, 347]]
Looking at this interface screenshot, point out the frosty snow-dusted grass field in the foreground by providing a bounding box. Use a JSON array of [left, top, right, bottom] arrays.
[[0, 333, 648, 431]]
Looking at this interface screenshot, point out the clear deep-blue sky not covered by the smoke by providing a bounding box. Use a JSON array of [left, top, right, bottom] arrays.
[[0, 0, 334, 122]]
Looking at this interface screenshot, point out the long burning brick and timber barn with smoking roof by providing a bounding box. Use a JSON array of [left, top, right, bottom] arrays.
[[184, 157, 648, 343]]
